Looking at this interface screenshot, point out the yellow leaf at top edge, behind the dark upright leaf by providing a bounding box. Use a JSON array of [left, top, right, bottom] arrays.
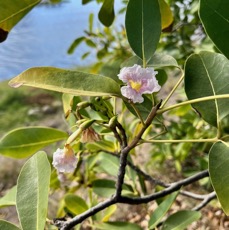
[[158, 0, 173, 30]]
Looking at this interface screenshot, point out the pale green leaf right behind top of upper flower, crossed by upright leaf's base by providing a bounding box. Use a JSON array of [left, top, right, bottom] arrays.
[[121, 53, 180, 68]]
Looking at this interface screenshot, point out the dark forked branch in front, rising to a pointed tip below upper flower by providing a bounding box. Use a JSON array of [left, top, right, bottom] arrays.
[[54, 103, 209, 230]]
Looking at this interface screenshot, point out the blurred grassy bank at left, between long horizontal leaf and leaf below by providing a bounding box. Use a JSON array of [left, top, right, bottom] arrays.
[[0, 81, 62, 137]]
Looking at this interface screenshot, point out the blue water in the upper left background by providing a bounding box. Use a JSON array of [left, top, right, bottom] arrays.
[[0, 0, 124, 80]]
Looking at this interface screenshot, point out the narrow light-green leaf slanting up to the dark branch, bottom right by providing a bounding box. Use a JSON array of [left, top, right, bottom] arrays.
[[149, 192, 179, 229]]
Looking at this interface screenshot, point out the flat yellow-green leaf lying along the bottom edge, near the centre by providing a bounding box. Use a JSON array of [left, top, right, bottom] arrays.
[[95, 221, 141, 230]]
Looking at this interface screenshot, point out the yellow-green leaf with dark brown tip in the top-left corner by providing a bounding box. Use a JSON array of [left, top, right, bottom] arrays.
[[0, 0, 41, 41]]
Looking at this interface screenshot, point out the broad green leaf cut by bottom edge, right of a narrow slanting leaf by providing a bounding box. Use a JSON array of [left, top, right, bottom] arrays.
[[162, 210, 201, 230]]
